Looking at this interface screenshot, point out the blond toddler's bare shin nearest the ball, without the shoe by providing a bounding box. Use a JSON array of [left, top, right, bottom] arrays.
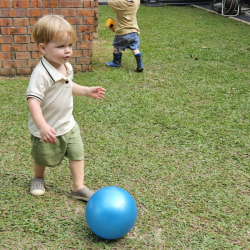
[[69, 160, 84, 191]]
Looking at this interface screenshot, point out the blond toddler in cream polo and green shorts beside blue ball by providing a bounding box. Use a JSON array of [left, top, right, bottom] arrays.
[[27, 15, 105, 201]]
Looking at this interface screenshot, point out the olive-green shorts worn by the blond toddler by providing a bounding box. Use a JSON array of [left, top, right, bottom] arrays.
[[30, 123, 84, 167]]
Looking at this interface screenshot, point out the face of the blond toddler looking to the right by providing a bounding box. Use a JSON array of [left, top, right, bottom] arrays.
[[39, 35, 73, 67]]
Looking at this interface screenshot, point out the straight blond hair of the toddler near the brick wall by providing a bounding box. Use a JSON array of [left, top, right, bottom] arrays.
[[32, 15, 76, 46]]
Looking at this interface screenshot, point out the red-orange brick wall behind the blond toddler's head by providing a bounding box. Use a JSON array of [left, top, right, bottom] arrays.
[[0, 0, 98, 76]]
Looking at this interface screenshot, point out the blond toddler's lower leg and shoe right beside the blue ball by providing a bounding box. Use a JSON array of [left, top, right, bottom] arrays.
[[69, 160, 94, 201]]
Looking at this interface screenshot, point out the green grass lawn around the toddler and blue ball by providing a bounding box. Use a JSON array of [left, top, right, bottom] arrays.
[[0, 6, 250, 250]]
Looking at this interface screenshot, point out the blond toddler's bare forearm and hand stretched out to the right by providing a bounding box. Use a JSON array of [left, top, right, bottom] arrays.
[[72, 83, 106, 99]]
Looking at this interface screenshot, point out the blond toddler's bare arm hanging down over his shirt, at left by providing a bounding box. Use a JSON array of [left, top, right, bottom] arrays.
[[28, 98, 56, 143]]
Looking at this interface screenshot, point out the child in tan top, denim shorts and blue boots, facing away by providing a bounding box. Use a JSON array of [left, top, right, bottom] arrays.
[[106, 0, 144, 72]]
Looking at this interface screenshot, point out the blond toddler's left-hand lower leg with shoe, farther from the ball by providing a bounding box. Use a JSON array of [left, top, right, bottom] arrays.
[[30, 163, 45, 195]]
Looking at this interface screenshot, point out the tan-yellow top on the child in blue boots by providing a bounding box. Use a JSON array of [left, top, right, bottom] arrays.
[[108, 0, 140, 36]]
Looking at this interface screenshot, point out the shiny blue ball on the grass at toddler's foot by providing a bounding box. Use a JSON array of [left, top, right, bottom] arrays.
[[85, 187, 137, 240]]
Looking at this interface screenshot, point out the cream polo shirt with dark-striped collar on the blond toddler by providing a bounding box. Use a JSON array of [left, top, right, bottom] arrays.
[[26, 57, 75, 138]]
